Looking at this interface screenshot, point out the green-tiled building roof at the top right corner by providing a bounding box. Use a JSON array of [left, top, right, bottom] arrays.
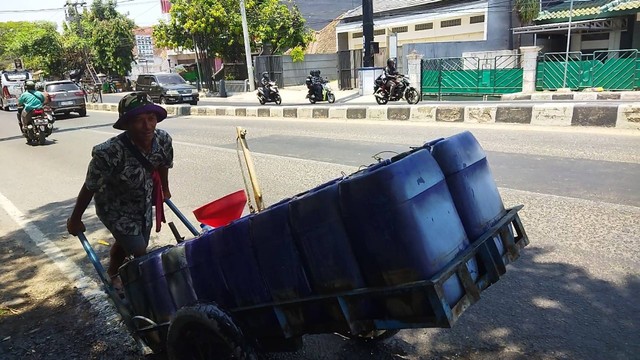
[[536, 0, 640, 21]]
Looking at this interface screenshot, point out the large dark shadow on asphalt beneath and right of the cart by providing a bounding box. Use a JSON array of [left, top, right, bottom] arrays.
[[268, 247, 640, 360]]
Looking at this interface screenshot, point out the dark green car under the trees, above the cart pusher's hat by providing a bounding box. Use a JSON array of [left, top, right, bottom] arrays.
[[136, 73, 200, 105]]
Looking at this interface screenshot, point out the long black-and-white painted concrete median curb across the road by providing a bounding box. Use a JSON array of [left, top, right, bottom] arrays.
[[87, 102, 640, 130]]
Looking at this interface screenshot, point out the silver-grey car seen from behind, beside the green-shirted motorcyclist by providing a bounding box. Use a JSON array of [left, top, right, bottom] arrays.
[[44, 80, 87, 116]]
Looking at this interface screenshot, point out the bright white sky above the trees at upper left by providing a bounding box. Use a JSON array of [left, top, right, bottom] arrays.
[[0, 0, 168, 31]]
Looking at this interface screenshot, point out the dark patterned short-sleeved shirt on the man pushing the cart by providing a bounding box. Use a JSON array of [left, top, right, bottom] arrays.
[[85, 129, 173, 235]]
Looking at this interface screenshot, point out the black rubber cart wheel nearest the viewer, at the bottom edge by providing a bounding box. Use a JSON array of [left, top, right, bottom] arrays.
[[167, 304, 258, 360]]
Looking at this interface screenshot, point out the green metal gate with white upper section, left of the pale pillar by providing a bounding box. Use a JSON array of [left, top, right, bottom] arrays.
[[421, 55, 522, 96]]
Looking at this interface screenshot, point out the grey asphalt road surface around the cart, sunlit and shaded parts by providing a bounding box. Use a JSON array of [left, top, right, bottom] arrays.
[[0, 112, 640, 360]]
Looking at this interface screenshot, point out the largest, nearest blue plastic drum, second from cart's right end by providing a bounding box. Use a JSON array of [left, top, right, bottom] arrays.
[[340, 150, 476, 306]]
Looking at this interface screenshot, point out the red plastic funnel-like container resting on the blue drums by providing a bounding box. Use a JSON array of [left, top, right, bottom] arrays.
[[193, 190, 247, 227]]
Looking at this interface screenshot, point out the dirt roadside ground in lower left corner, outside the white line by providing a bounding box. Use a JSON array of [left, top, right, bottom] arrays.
[[0, 229, 144, 360]]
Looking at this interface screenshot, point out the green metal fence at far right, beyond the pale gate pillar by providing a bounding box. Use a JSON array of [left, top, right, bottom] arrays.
[[536, 49, 640, 90]]
